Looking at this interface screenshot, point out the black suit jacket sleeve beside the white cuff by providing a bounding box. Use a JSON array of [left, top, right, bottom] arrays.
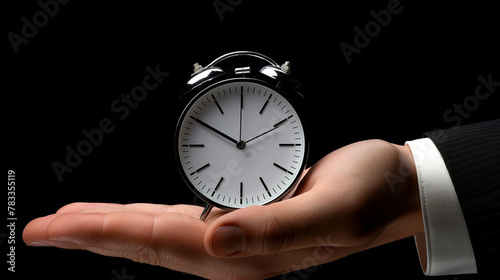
[[426, 119, 500, 279]]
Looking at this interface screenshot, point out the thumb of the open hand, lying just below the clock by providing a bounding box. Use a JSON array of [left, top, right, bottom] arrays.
[[204, 192, 344, 257]]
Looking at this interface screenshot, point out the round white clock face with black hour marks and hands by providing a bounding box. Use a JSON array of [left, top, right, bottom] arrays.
[[177, 80, 306, 208]]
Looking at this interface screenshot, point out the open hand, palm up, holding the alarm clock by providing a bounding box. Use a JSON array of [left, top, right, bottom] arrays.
[[23, 140, 423, 279]]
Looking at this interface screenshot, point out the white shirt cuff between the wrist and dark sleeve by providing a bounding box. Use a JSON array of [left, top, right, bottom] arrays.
[[406, 138, 477, 276]]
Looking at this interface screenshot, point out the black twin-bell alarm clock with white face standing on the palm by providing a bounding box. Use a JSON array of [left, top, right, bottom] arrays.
[[175, 51, 308, 220]]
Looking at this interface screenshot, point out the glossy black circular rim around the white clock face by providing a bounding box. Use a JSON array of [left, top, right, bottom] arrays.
[[174, 77, 309, 211]]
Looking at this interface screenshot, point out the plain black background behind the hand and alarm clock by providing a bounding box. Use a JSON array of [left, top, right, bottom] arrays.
[[0, 0, 500, 280]]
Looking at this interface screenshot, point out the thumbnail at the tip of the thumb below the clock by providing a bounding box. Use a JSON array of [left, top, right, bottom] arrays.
[[210, 226, 243, 257]]
